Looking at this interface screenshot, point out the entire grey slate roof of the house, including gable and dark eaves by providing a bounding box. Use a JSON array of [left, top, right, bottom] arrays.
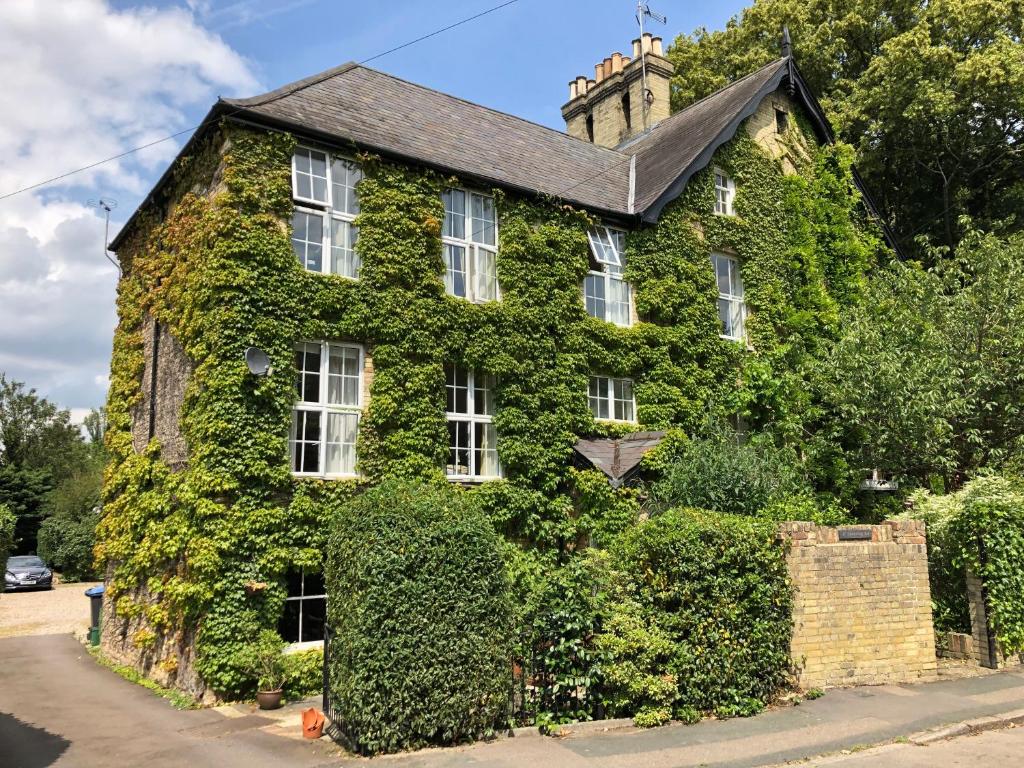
[[111, 56, 895, 251]]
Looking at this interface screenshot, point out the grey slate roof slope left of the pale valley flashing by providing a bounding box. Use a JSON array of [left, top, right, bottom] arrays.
[[222, 63, 630, 213]]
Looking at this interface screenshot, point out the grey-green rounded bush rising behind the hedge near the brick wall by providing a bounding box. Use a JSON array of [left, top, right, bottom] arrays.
[[650, 431, 809, 515]]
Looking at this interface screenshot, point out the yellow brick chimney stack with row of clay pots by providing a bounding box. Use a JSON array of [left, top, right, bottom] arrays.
[[562, 33, 672, 146]]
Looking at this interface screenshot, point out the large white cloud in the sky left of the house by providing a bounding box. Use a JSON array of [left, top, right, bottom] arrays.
[[0, 0, 261, 409]]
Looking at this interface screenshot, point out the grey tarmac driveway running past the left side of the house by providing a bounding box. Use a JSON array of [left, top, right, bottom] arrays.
[[0, 634, 348, 768]]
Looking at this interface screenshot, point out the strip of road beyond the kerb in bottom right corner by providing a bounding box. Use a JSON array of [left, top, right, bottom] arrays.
[[807, 728, 1024, 768]]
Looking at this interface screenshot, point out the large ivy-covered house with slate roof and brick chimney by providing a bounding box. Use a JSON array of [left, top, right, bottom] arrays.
[[97, 36, 880, 697]]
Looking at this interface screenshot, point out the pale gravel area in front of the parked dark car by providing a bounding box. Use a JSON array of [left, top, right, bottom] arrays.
[[0, 582, 98, 637]]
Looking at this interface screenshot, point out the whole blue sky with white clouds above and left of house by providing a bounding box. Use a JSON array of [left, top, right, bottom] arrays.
[[0, 0, 742, 418]]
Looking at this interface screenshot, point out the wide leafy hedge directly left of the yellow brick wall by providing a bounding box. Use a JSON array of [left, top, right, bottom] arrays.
[[597, 510, 793, 725]]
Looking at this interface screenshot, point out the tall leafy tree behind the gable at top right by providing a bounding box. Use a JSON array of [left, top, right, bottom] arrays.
[[668, 0, 1024, 256]]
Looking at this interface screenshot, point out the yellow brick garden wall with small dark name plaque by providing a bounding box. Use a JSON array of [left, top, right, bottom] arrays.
[[779, 520, 936, 688]]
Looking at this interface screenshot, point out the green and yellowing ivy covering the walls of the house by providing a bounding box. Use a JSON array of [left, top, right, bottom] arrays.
[[97, 105, 876, 697]]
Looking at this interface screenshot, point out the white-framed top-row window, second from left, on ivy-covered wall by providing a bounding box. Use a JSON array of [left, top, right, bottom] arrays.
[[441, 188, 501, 303]]
